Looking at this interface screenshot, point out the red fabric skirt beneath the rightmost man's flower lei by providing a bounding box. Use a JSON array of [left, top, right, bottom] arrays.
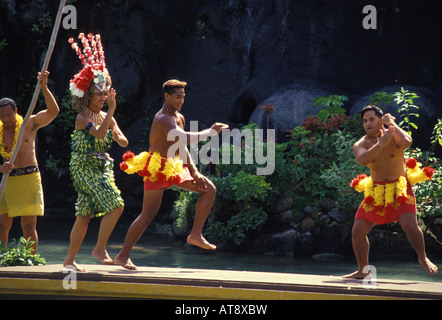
[[355, 180, 416, 224]]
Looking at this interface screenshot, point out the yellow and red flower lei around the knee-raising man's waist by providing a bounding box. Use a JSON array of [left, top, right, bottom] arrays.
[[120, 151, 183, 182]]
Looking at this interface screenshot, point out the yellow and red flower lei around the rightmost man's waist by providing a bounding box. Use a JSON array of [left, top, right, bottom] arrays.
[[350, 158, 435, 213]]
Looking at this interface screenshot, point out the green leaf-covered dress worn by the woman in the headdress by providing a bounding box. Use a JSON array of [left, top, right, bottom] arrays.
[[69, 130, 124, 217]]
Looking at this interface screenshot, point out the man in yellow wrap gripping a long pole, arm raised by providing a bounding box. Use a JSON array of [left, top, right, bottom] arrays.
[[0, 71, 59, 252]]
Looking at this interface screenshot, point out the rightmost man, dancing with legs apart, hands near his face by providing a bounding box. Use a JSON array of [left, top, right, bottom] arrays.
[[344, 105, 438, 279]]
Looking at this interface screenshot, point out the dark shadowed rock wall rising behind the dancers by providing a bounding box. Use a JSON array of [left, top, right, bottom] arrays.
[[0, 0, 442, 228]]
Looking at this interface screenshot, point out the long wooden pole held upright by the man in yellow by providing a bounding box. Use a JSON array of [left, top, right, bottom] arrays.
[[0, 0, 66, 199]]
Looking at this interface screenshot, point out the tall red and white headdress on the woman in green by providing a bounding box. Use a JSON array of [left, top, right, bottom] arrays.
[[68, 33, 109, 98]]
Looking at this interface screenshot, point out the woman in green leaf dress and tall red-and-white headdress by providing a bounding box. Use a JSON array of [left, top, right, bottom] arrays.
[[63, 34, 128, 271]]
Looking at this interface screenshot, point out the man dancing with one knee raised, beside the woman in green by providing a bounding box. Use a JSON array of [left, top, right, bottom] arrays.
[[115, 80, 228, 270]]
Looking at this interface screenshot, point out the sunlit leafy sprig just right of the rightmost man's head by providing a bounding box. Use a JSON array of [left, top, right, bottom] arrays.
[[393, 88, 419, 136]]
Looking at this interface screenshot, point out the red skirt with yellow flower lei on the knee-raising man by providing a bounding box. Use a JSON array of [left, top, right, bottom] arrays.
[[120, 151, 194, 191]]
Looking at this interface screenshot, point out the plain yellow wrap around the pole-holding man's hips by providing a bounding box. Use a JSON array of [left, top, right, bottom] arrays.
[[0, 172, 44, 217]]
